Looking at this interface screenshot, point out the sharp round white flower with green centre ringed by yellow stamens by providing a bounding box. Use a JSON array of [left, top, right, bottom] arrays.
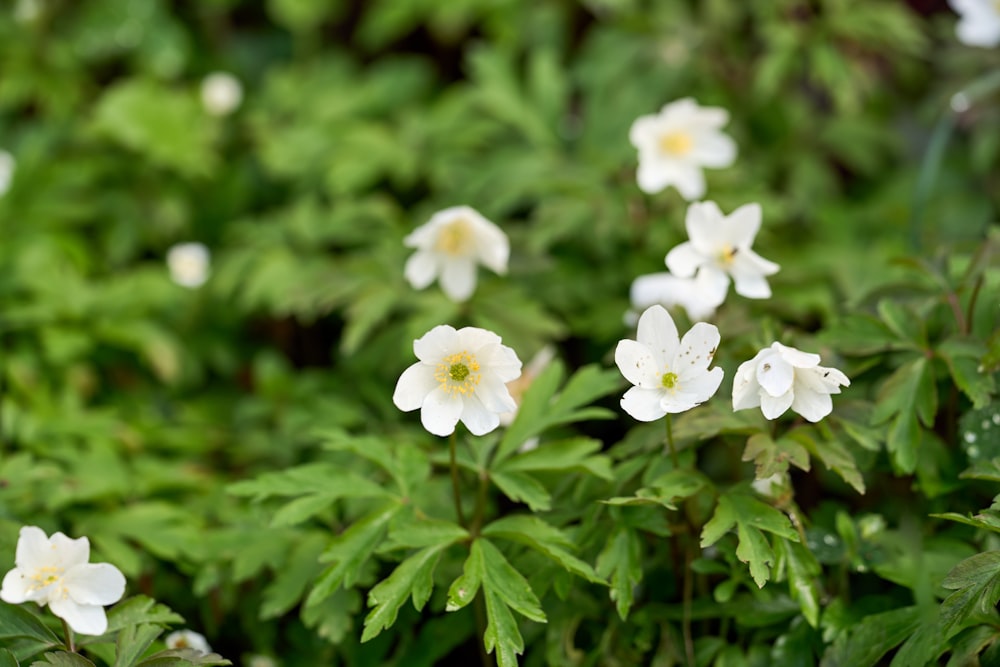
[[392, 325, 521, 435]]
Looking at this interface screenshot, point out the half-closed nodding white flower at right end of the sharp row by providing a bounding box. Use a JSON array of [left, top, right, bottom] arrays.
[[733, 343, 851, 422]]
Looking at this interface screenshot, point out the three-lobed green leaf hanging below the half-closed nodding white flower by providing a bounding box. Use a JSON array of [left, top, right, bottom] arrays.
[[701, 494, 799, 588]]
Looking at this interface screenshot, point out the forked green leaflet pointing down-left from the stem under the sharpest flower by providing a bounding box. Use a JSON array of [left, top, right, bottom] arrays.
[[361, 544, 448, 642]]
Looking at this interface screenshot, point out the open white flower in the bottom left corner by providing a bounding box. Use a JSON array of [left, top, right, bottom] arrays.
[[0, 526, 125, 635]]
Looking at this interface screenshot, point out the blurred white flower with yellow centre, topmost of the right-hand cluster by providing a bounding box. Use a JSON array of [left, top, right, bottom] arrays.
[[629, 97, 736, 201]]
